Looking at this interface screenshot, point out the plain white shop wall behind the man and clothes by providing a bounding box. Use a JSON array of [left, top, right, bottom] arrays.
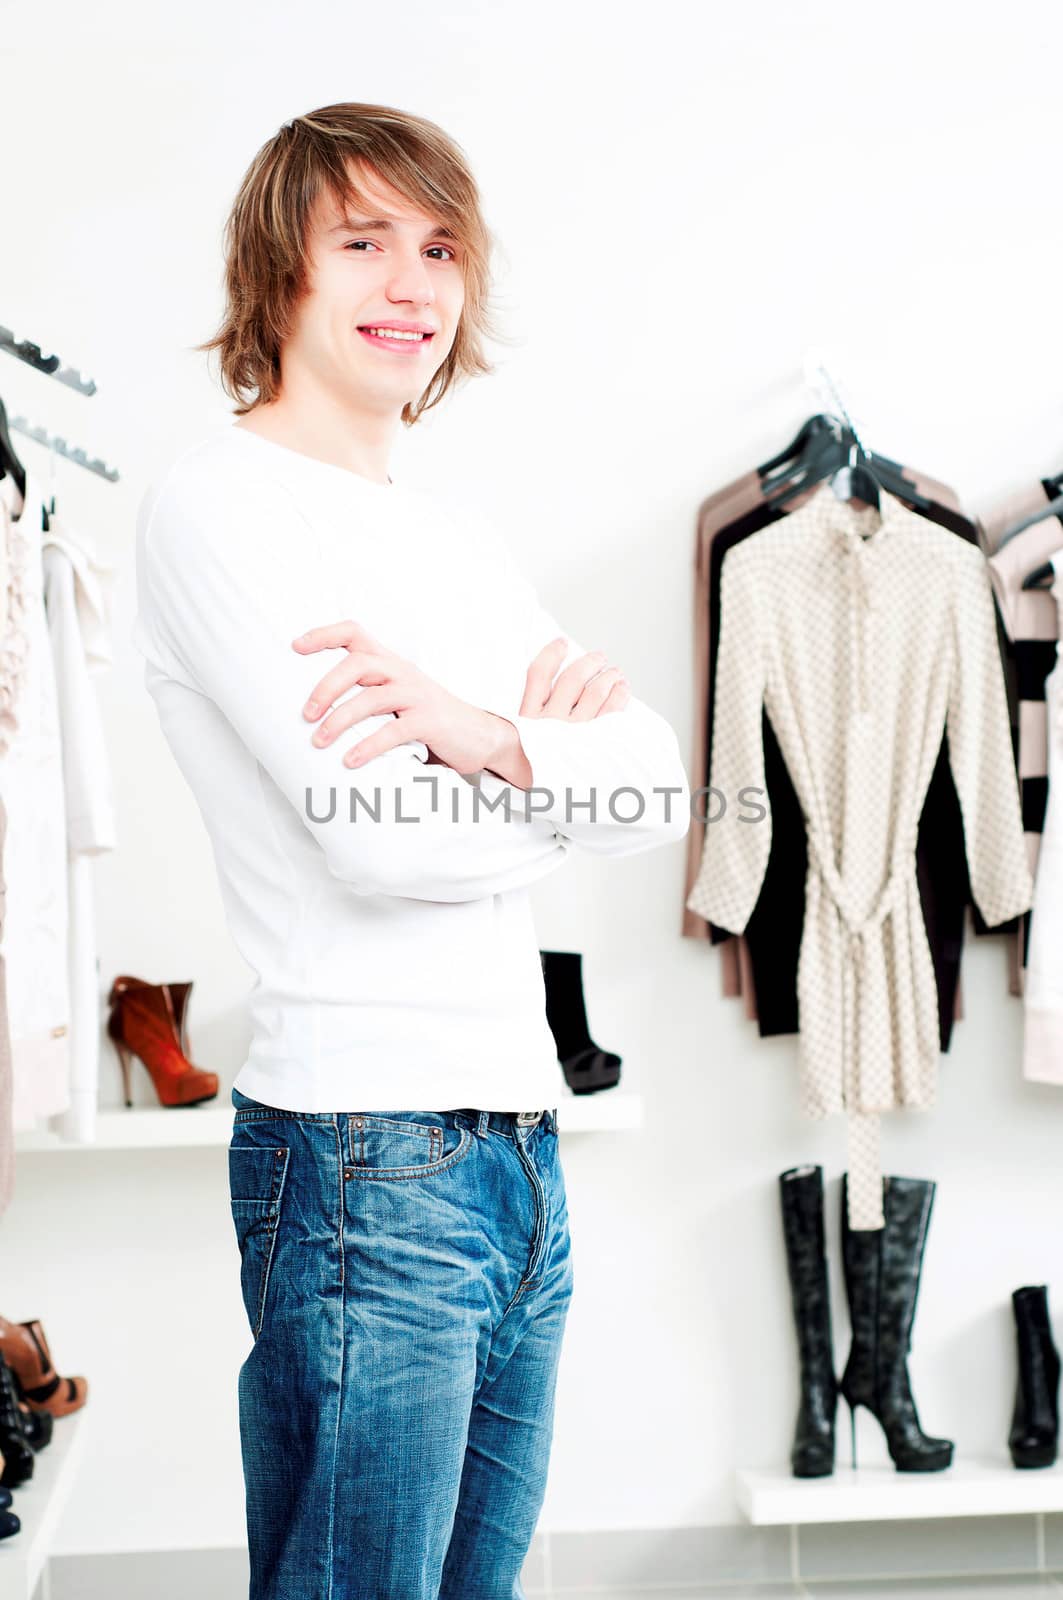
[[0, 0, 1063, 1550]]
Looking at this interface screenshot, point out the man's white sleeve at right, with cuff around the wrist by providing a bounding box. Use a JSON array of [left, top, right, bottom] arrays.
[[480, 534, 690, 856]]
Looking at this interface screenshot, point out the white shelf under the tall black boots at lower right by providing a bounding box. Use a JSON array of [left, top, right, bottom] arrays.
[[735, 1454, 1063, 1525]]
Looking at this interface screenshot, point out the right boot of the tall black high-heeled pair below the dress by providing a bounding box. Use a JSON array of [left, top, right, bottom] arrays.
[[840, 1173, 953, 1472]]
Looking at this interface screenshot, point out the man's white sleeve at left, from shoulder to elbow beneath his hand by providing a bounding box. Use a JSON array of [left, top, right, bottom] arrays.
[[133, 460, 570, 901]]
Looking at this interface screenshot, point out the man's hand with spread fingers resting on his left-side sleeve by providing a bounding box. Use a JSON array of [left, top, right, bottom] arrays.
[[291, 621, 505, 773]]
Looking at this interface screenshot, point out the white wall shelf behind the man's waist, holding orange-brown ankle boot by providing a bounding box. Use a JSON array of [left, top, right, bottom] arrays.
[[14, 1088, 642, 1154]]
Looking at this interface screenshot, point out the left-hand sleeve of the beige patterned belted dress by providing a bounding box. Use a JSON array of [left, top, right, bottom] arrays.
[[687, 542, 772, 933]]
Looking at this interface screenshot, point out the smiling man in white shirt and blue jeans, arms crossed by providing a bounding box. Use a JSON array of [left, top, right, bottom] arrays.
[[136, 104, 690, 1600]]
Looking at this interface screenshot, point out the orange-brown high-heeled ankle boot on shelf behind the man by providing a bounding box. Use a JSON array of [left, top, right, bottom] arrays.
[[107, 974, 218, 1106]]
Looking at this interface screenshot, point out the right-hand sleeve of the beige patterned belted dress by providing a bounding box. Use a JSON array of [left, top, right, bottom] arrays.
[[946, 547, 1034, 928]]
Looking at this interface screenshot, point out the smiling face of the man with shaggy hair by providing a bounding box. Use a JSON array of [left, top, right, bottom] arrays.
[[283, 166, 464, 413]]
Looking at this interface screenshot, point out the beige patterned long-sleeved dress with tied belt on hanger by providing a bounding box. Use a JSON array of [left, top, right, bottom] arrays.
[[687, 483, 1033, 1229]]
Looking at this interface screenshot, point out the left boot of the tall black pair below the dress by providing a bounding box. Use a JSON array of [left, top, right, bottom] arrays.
[[778, 1166, 837, 1478]]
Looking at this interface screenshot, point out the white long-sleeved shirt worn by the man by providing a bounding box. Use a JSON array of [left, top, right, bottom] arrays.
[[133, 422, 690, 1112]]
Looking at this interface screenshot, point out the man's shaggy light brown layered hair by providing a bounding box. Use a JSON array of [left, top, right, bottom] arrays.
[[197, 102, 499, 426]]
